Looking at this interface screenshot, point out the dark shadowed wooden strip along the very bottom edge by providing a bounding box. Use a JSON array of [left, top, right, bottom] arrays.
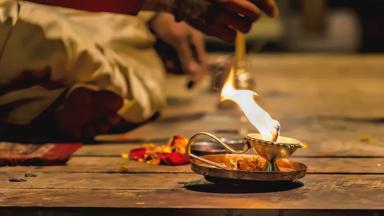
[[0, 207, 383, 216]]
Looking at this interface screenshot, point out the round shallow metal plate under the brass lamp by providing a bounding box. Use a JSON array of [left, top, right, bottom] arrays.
[[191, 154, 307, 183]]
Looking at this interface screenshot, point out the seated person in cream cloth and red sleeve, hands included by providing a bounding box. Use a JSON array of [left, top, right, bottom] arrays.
[[0, 0, 277, 138]]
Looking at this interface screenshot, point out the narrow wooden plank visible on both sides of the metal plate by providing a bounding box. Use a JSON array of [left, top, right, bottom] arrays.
[[0, 157, 384, 175]]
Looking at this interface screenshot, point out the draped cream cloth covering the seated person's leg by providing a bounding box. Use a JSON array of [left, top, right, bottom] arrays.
[[0, 0, 164, 125]]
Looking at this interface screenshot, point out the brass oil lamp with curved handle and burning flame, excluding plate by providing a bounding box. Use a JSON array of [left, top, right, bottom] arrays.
[[187, 68, 303, 175]]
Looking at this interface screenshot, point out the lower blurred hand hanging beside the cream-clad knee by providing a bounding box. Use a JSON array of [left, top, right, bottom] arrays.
[[150, 13, 207, 81]]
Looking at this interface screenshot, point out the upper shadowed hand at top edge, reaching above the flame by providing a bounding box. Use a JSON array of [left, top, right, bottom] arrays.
[[142, 0, 279, 42]]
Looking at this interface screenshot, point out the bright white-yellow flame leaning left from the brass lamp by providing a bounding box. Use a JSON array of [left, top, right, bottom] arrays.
[[220, 68, 280, 141]]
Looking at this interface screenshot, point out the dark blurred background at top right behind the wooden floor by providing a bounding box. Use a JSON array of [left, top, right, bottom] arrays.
[[206, 0, 384, 53]]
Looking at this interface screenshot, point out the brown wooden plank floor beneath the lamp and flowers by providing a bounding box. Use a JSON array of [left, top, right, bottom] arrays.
[[0, 55, 384, 215]]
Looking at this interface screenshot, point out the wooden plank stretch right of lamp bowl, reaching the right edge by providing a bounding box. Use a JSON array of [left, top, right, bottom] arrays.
[[282, 119, 384, 157]]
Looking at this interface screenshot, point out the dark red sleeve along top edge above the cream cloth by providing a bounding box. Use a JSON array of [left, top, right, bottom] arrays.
[[27, 0, 144, 15]]
